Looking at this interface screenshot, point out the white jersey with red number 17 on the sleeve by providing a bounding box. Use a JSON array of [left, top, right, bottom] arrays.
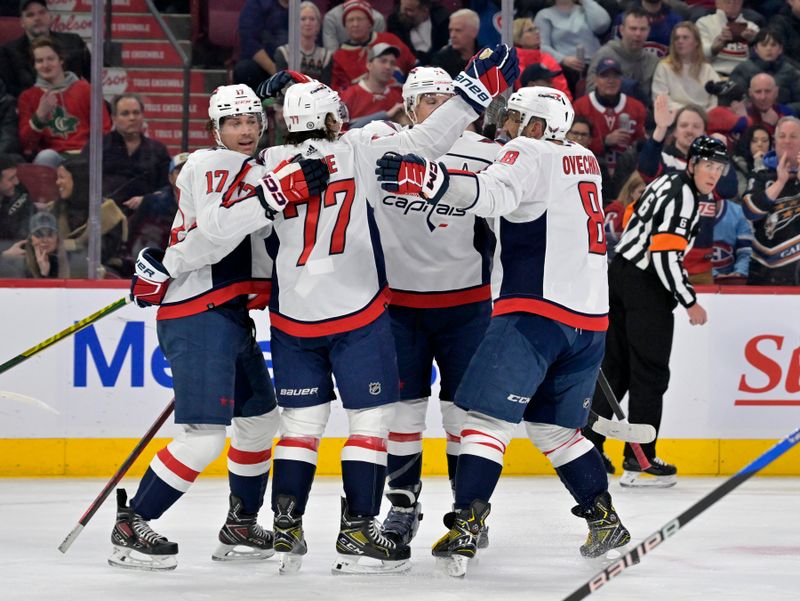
[[158, 148, 272, 319]]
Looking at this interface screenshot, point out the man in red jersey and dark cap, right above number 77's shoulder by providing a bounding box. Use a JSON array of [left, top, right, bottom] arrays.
[[341, 44, 403, 127]]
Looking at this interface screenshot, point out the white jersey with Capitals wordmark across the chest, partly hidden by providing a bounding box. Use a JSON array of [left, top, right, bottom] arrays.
[[375, 131, 500, 308]]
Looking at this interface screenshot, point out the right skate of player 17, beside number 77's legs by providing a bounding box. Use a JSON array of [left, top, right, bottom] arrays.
[[211, 495, 275, 561]]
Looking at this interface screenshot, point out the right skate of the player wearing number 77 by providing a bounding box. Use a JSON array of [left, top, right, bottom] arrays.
[[331, 498, 411, 574]]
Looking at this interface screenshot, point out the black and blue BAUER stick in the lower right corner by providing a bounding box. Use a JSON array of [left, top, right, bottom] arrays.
[[564, 428, 800, 601]]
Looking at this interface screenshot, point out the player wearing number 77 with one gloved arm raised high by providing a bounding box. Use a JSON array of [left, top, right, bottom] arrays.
[[247, 46, 518, 572]]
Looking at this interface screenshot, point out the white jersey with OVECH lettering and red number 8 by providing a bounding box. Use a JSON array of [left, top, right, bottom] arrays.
[[442, 137, 608, 331]]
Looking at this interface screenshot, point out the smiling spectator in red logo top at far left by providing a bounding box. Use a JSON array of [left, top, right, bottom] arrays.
[[17, 37, 111, 167]]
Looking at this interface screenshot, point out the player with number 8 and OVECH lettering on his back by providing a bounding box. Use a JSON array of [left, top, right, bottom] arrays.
[[378, 87, 630, 576]]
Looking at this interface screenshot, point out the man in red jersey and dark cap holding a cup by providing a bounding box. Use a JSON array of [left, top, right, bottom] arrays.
[[574, 58, 647, 176]]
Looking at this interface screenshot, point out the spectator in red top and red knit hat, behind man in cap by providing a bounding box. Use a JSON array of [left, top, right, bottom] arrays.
[[331, 0, 417, 91]]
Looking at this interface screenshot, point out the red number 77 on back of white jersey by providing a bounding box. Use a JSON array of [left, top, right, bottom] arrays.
[[283, 178, 356, 267]]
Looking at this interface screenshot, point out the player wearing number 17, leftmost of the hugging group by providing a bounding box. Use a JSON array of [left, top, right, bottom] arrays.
[[109, 85, 327, 570]]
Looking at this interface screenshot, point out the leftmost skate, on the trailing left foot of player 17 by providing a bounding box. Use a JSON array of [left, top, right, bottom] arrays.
[[108, 488, 178, 571]]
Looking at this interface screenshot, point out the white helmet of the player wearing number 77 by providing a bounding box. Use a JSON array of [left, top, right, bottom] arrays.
[[283, 80, 350, 132]]
